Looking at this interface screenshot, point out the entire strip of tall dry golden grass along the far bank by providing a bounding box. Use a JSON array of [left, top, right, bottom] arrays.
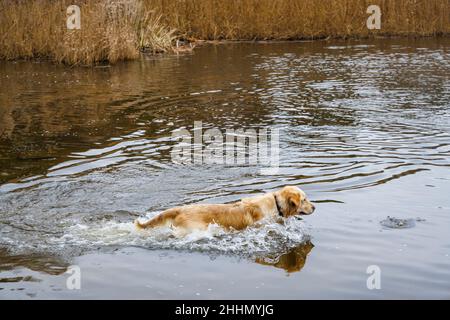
[[0, 0, 450, 64]]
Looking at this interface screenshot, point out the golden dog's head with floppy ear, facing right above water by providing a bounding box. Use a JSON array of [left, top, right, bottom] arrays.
[[275, 186, 315, 217]]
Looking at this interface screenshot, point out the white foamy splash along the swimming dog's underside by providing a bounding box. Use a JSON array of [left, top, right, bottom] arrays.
[[60, 214, 310, 256]]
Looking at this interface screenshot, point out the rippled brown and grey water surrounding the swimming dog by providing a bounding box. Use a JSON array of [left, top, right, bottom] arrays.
[[0, 39, 450, 299]]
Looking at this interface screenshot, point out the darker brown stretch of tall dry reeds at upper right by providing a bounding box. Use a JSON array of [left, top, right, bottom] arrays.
[[144, 0, 450, 40]]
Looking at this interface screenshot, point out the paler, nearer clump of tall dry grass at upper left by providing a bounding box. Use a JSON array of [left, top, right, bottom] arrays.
[[0, 0, 174, 65]]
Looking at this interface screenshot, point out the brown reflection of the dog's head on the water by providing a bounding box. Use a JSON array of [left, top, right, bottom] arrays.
[[255, 241, 314, 273]]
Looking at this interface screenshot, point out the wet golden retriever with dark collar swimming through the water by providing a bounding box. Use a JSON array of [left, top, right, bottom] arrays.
[[135, 186, 315, 236]]
